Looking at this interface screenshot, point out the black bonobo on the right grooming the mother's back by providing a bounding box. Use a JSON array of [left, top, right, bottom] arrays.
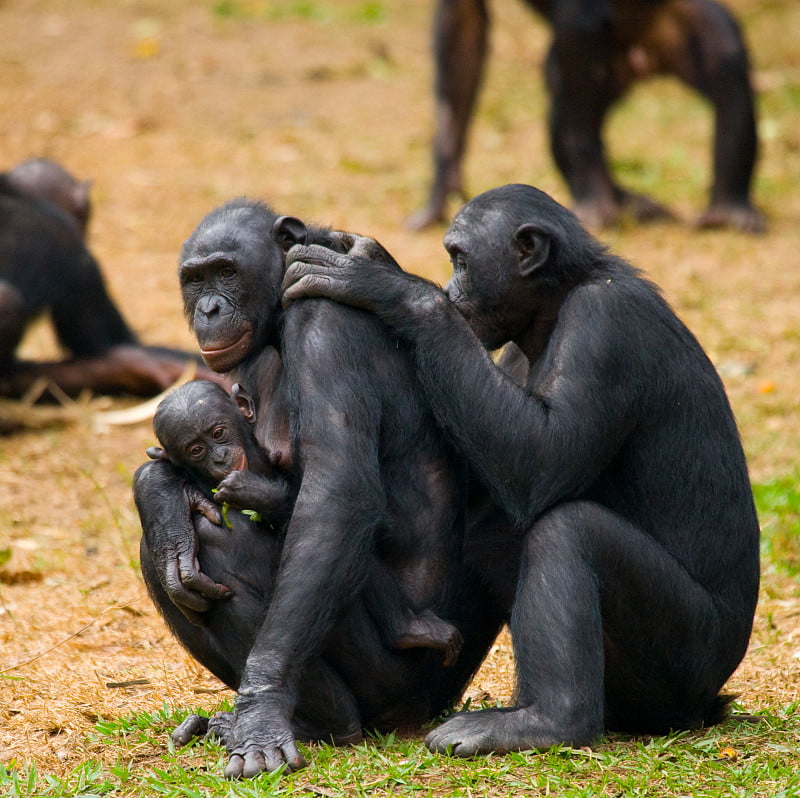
[[284, 185, 759, 755]]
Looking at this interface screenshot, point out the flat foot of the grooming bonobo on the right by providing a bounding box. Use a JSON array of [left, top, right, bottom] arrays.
[[425, 707, 600, 756]]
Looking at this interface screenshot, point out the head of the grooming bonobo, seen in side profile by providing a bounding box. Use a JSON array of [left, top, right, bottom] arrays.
[[444, 184, 605, 349]]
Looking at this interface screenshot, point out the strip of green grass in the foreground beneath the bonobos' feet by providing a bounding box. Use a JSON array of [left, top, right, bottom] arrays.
[[0, 703, 800, 798]]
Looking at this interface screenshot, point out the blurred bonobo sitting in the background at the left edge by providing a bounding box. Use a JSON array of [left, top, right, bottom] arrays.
[[0, 159, 214, 397]]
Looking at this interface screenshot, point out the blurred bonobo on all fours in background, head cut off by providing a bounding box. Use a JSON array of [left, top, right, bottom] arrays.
[[409, 0, 765, 233]]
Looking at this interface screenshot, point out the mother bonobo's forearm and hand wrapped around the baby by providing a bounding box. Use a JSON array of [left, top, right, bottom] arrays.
[[133, 460, 230, 625]]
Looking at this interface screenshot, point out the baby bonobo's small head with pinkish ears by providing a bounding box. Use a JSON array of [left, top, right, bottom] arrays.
[[147, 380, 262, 486]]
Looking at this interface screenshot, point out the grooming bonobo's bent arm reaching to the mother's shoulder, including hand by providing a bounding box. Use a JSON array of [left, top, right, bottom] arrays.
[[284, 239, 635, 524]]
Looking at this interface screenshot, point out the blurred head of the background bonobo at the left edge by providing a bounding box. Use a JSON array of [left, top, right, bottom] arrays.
[[5, 158, 92, 237]]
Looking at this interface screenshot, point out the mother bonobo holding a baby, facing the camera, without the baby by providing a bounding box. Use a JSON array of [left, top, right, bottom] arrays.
[[134, 200, 502, 776]]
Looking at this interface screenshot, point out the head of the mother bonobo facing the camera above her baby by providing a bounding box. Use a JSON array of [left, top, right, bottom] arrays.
[[183, 199, 326, 372]]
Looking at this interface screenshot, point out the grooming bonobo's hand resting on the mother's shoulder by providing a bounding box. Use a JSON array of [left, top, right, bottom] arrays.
[[282, 233, 429, 320]]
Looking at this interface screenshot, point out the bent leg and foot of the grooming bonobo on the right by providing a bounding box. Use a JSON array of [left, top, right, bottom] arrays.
[[427, 502, 750, 756]]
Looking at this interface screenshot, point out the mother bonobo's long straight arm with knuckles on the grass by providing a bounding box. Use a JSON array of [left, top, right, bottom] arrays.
[[226, 302, 384, 777]]
